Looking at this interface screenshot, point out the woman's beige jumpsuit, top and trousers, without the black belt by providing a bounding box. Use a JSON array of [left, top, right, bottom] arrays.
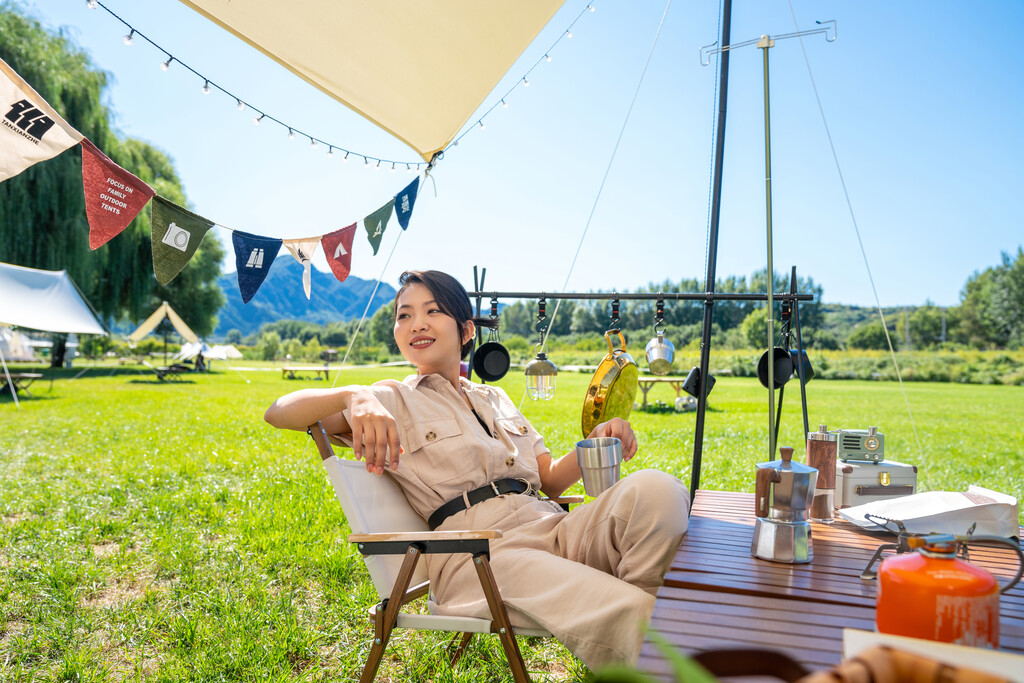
[[345, 375, 689, 669]]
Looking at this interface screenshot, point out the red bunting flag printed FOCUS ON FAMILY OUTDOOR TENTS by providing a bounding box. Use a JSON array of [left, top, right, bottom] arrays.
[[81, 137, 155, 250]]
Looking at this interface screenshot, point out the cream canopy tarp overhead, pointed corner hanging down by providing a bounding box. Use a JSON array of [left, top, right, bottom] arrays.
[[174, 0, 564, 161]]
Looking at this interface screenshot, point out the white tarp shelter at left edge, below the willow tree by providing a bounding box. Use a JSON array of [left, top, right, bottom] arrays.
[[0, 263, 106, 335]]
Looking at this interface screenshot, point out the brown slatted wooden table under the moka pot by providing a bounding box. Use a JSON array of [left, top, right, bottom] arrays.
[[637, 490, 1024, 681]]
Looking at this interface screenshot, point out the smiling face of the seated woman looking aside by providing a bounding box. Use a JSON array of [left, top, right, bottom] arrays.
[[394, 283, 472, 375]]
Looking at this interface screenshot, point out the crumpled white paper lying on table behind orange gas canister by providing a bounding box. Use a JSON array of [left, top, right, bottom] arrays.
[[839, 485, 1020, 539]]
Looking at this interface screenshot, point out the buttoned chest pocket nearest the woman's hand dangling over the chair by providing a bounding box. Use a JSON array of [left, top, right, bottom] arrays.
[[401, 418, 475, 486]]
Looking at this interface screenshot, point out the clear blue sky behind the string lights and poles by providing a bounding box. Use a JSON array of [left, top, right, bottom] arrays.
[[16, 0, 1024, 305]]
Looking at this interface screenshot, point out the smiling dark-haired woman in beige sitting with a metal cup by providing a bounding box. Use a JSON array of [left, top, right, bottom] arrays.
[[265, 270, 689, 669]]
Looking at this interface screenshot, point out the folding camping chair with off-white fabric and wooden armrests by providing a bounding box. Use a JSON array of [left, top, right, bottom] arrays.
[[309, 422, 583, 683]]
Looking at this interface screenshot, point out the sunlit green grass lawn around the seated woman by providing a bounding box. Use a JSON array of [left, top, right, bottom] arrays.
[[0, 361, 1024, 681]]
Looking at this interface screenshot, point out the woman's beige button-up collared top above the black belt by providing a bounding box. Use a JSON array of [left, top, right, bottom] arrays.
[[339, 375, 548, 519]]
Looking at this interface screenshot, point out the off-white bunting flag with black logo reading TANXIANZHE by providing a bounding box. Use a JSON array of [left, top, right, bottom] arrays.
[[0, 59, 83, 181]]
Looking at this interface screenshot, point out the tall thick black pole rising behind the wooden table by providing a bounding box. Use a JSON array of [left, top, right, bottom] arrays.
[[690, 0, 732, 501]]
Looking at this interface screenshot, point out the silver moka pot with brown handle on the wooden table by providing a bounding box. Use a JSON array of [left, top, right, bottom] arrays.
[[751, 446, 818, 564]]
